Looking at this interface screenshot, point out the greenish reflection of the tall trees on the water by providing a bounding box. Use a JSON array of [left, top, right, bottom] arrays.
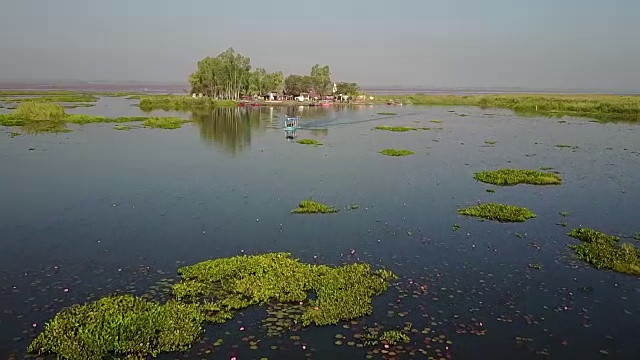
[[191, 108, 268, 154]]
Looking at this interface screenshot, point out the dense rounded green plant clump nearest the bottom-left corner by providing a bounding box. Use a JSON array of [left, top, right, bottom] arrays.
[[28, 295, 204, 360]]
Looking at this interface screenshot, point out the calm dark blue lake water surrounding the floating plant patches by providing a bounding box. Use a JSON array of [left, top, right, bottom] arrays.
[[0, 98, 640, 360]]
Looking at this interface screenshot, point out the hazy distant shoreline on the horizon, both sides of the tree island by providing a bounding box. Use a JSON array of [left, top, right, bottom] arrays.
[[0, 81, 640, 95]]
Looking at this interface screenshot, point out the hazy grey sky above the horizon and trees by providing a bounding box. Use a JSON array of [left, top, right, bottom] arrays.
[[0, 0, 640, 89]]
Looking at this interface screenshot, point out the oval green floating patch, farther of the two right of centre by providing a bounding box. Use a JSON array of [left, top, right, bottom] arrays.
[[473, 169, 562, 186]]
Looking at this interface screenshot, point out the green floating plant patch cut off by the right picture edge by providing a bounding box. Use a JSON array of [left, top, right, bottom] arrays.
[[567, 228, 640, 276]]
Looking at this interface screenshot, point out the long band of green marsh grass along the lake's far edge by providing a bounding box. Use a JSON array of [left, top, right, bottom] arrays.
[[0, 90, 640, 122]]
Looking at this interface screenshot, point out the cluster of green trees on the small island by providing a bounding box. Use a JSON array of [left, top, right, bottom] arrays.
[[189, 48, 359, 100]]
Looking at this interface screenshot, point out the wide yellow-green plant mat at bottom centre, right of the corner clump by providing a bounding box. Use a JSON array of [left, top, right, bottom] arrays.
[[173, 253, 396, 326]]
